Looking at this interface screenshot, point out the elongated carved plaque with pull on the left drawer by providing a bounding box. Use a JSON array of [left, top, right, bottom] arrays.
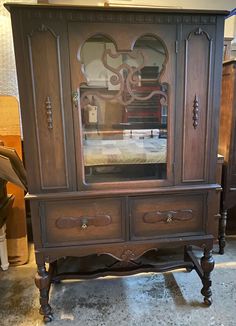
[[56, 215, 111, 230]]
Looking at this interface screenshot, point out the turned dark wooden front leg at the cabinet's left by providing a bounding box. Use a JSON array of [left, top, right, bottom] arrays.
[[35, 264, 53, 322]]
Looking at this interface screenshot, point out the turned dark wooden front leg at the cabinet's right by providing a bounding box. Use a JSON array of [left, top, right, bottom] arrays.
[[201, 248, 215, 306]]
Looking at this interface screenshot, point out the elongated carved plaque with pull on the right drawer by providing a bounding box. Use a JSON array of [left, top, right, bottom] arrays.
[[143, 209, 193, 224]]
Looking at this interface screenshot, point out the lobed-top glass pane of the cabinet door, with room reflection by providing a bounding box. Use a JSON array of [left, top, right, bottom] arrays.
[[78, 35, 168, 182]]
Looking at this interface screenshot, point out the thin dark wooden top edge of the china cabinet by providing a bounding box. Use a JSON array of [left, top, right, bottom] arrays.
[[4, 2, 229, 15]]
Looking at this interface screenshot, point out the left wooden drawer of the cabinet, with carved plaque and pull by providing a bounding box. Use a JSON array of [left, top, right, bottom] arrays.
[[40, 198, 125, 247]]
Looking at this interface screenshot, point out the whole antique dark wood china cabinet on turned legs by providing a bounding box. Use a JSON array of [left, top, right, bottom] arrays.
[[6, 3, 226, 321]]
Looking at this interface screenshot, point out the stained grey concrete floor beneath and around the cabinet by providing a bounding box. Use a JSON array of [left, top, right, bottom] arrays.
[[0, 237, 236, 326]]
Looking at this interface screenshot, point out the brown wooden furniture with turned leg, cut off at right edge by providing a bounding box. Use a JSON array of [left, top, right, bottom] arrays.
[[219, 59, 236, 254]]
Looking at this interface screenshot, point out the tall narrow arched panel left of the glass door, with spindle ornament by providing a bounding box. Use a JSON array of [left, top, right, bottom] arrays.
[[28, 28, 68, 189]]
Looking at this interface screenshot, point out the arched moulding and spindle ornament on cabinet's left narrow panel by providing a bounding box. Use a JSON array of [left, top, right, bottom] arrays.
[[27, 24, 69, 190]]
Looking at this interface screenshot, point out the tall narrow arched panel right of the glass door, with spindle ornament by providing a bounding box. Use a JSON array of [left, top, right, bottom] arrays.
[[182, 28, 212, 182]]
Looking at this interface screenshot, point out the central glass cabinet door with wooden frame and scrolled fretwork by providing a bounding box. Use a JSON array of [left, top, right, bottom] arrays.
[[69, 22, 176, 189]]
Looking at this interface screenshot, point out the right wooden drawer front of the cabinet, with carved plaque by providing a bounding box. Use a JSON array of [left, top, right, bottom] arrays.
[[130, 194, 206, 240]]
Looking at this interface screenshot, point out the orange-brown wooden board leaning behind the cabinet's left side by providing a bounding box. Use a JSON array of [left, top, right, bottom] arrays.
[[0, 95, 29, 265]]
